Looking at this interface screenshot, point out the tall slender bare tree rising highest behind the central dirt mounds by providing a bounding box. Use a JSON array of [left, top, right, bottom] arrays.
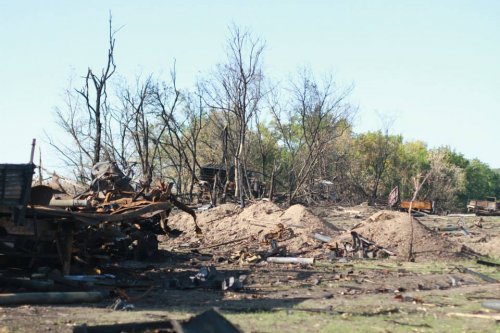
[[205, 26, 264, 206]]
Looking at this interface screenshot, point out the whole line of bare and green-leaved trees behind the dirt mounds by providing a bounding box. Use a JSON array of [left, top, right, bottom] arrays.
[[49, 19, 500, 210]]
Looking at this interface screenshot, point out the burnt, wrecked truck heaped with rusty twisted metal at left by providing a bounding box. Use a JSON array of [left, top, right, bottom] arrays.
[[0, 142, 201, 275]]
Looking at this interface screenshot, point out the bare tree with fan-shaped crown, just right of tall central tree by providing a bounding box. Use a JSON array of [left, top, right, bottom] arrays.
[[270, 70, 353, 204]]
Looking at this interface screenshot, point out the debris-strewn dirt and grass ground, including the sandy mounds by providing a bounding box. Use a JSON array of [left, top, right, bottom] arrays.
[[0, 201, 500, 333]]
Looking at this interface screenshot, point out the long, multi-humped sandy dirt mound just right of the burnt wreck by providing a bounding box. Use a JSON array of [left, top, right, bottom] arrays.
[[168, 201, 338, 254]]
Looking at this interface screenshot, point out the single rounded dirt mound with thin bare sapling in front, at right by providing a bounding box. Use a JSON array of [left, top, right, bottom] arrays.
[[333, 210, 461, 260]]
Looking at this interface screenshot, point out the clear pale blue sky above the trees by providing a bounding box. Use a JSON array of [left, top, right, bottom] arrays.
[[0, 0, 500, 169]]
